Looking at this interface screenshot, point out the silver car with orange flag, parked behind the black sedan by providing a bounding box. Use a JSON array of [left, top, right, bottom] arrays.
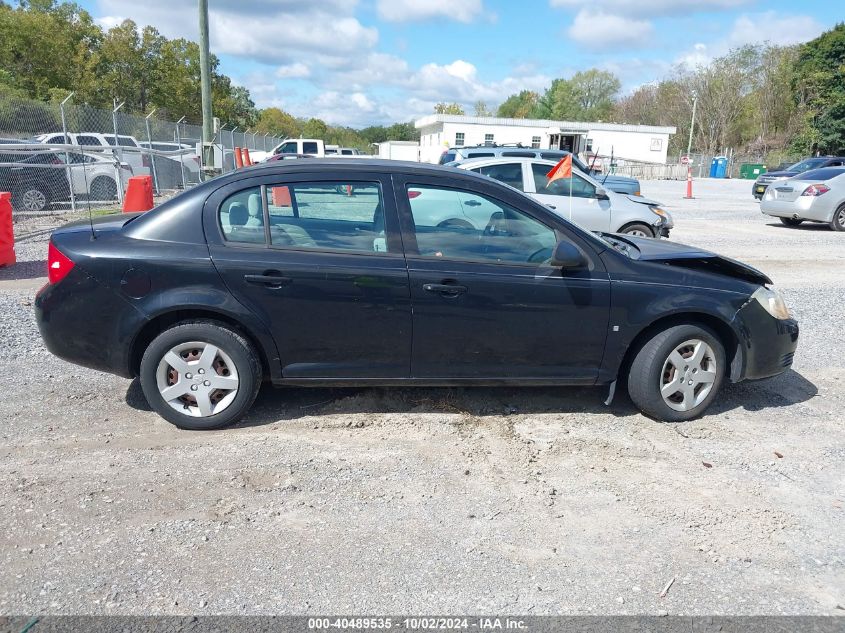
[[454, 158, 674, 237]]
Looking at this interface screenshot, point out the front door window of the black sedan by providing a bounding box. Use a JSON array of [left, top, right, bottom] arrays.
[[408, 185, 557, 265]]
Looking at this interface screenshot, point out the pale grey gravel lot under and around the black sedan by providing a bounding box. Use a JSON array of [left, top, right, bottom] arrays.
[[0, 180, 845, 615]]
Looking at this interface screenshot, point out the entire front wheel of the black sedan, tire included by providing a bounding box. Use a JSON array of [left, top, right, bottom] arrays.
[[628, 325, 726, 422]]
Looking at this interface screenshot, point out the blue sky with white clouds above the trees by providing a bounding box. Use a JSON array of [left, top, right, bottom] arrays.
[[79, 0, 845, 127]]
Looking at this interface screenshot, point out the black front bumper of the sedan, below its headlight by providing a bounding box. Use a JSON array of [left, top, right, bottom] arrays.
[[731, 301, 798, 382]]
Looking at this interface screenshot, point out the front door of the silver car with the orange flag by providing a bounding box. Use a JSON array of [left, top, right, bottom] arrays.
[[526, 162, 612, 231]]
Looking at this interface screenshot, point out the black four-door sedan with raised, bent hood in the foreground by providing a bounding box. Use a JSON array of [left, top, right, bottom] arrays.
[[35, 159, 798, 429]]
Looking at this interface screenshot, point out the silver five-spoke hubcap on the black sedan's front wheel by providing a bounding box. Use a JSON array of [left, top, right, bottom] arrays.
[[660, 339, 719, 411]]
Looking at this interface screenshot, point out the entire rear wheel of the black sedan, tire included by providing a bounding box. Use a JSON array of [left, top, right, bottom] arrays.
[[140, 321, 261, 430]]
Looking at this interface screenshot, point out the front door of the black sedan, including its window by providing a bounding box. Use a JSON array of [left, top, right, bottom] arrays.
[[394, 176, 610, 384]]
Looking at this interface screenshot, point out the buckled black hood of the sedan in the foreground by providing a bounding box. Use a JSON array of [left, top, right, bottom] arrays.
[[613, 235, 772, 284]]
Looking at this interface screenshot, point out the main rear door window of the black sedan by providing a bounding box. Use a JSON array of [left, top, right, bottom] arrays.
[[265, 182, 387, 254]]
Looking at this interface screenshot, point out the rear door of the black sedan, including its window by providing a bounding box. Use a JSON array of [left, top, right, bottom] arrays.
[[204, 172, 411, 381]]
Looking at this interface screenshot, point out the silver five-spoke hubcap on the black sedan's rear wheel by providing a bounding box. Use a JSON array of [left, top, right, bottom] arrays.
[[156, 341, 240, 417]]
